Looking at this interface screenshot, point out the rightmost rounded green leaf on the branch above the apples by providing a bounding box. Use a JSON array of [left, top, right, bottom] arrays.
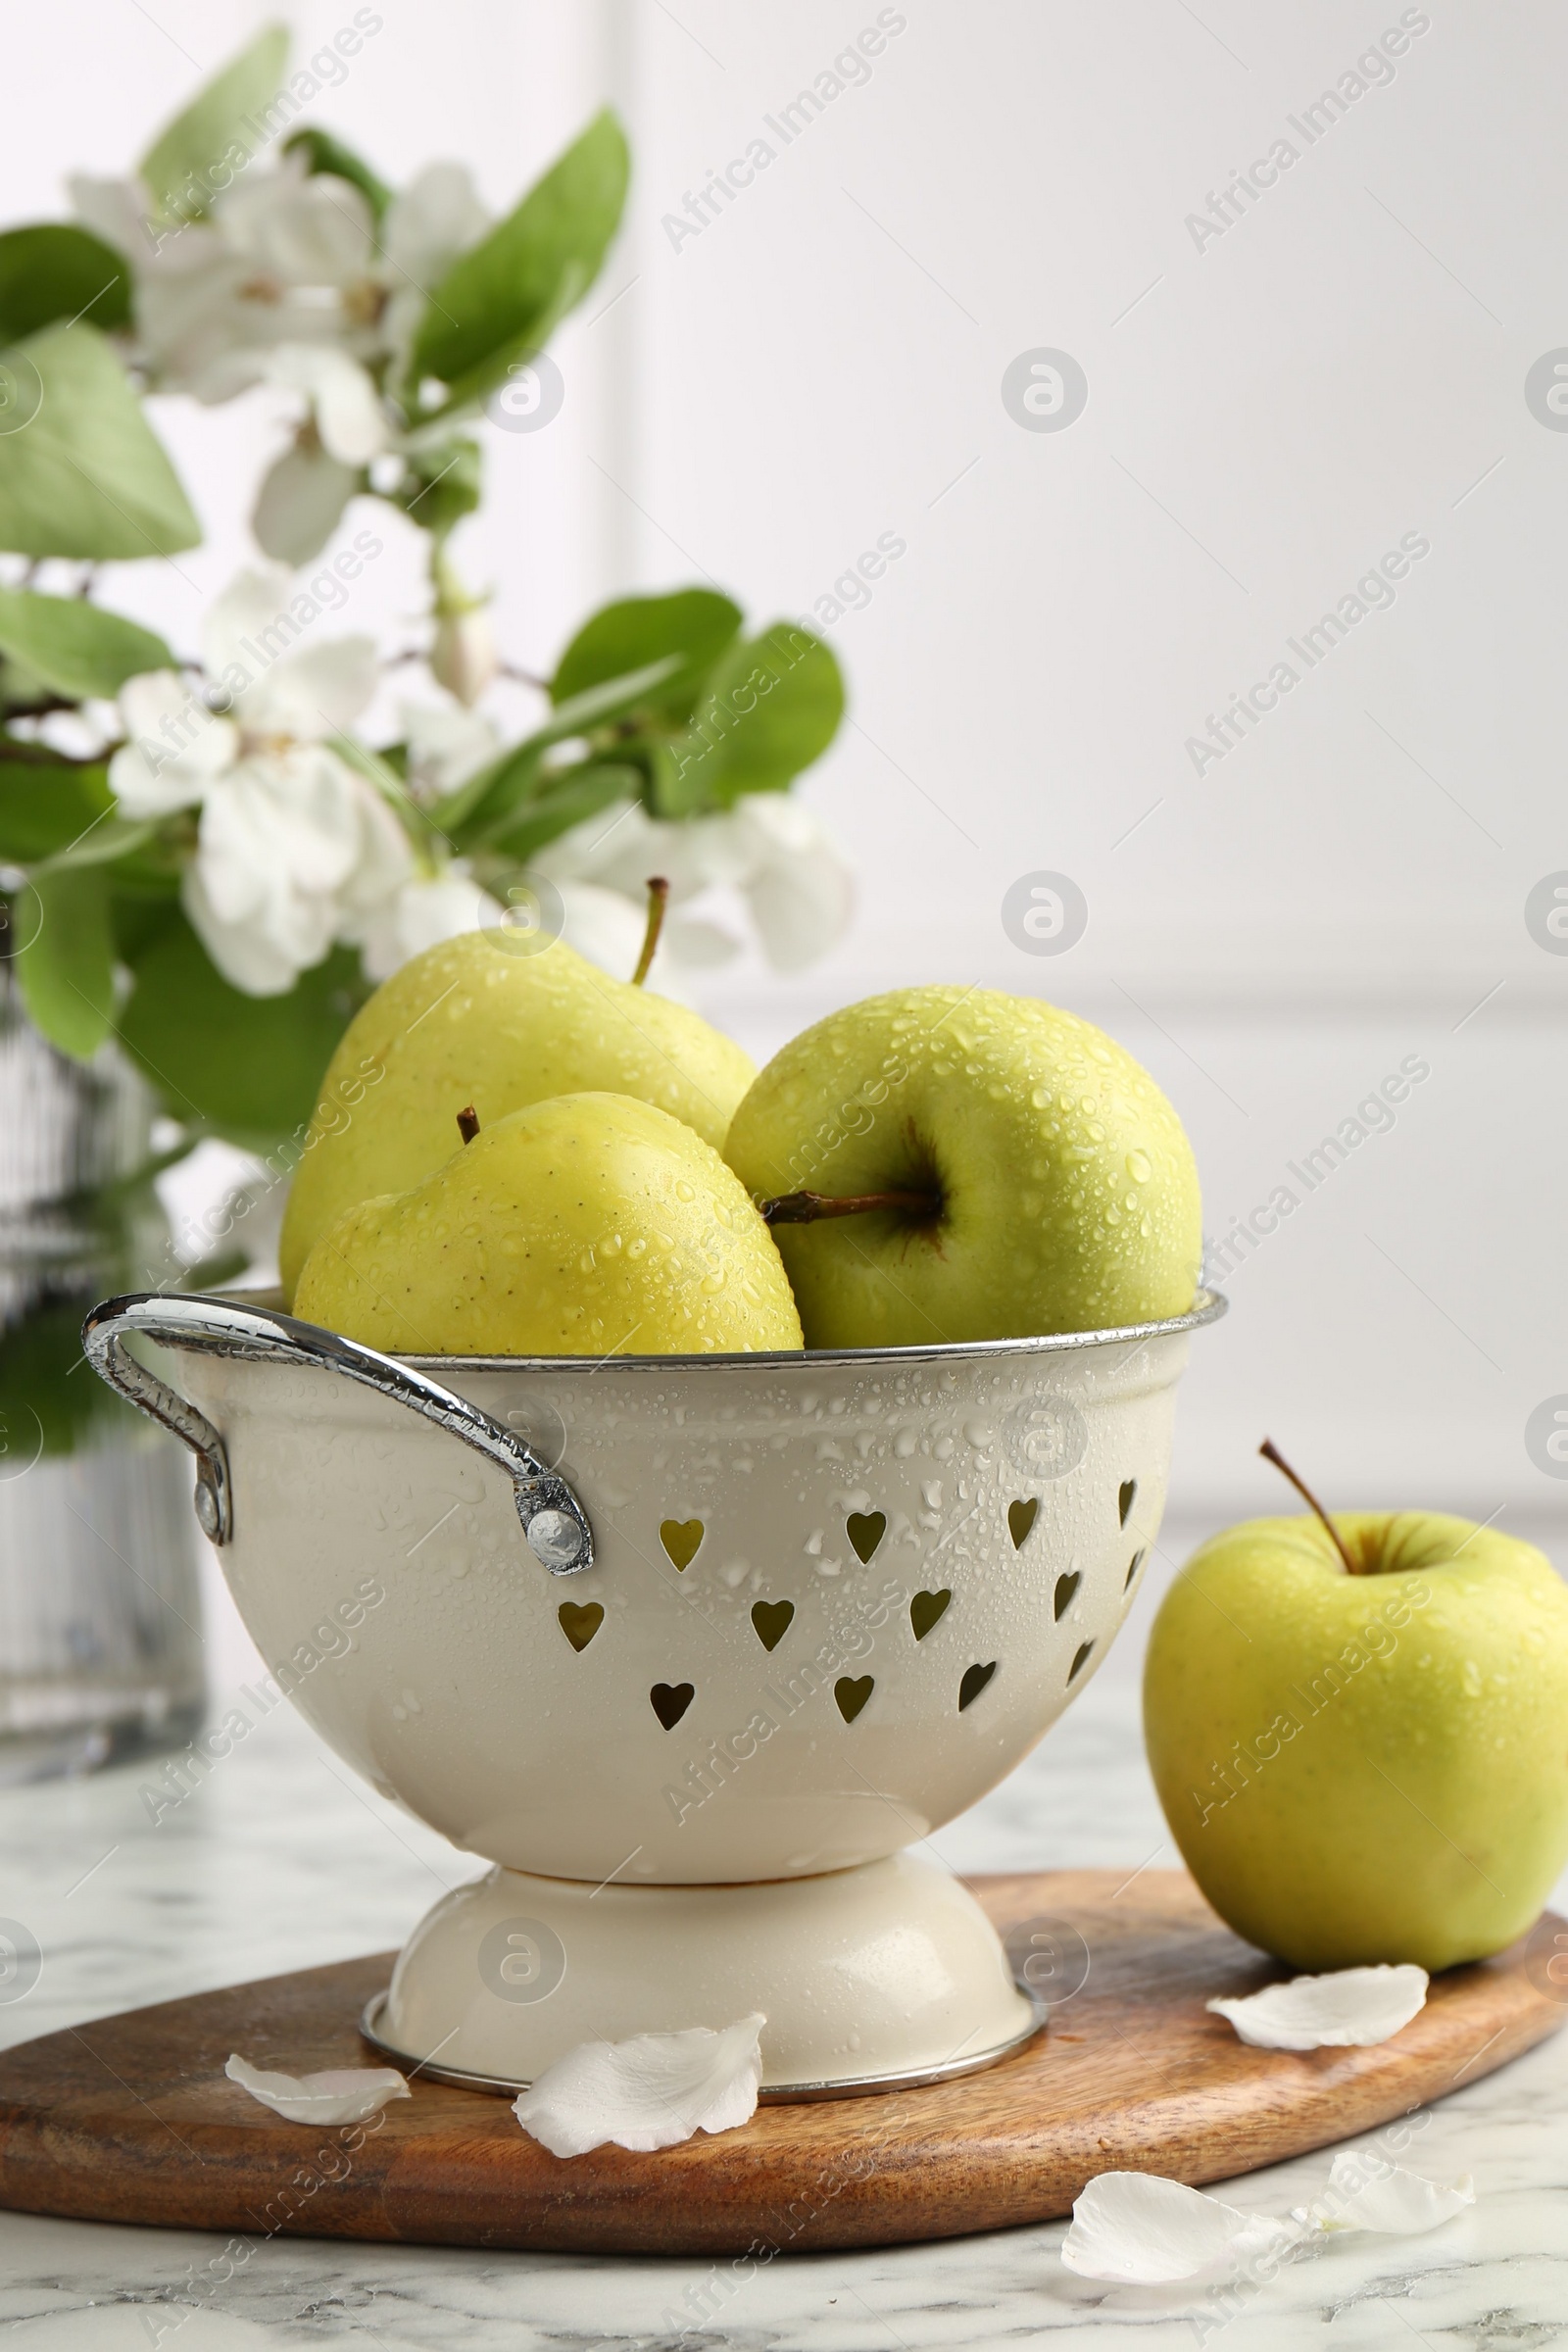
[[659, 621, 844, 816]]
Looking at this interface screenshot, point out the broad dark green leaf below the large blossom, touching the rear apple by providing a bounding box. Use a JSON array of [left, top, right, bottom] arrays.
[[120, 915, 369, 1151]]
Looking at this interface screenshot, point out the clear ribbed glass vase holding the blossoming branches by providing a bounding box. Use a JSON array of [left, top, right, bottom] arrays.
[[0, 964, 205, 1786]]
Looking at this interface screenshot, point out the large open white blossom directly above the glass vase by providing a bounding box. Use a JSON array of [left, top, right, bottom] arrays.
[[108, 566, 414, 998]]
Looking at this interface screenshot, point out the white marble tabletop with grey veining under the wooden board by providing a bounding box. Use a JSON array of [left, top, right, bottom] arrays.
[[0, 1536, 1568, 2352]]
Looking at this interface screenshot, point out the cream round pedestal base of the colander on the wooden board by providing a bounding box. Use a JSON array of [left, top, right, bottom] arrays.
[[362, 1853, 1042, 2100]]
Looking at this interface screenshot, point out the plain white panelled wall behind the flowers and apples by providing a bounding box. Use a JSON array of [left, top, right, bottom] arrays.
[[0, 0, 1568, 1561]]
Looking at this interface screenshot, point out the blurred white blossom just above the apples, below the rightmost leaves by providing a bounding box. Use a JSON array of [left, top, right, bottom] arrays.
[[534, 793, 854, 974]]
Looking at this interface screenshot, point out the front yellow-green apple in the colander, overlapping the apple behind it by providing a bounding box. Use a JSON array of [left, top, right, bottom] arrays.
[[294, 1094, 802, 1354]]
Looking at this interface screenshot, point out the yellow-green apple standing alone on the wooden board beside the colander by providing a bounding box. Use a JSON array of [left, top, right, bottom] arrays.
[[1143, 1456, 1568, 1971]]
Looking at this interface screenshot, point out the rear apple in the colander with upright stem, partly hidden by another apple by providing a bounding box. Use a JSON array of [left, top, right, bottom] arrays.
[[279, 882, 755, 1305]]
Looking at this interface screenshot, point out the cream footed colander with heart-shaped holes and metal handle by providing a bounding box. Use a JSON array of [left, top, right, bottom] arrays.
[[84, 1294, 1225, 2093]]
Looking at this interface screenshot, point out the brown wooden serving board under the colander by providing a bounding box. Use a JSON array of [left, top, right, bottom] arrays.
[[0, 1870, 1568, 2256]]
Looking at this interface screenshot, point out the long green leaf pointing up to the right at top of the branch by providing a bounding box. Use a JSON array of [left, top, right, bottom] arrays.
[[412, 111, 630, 414]]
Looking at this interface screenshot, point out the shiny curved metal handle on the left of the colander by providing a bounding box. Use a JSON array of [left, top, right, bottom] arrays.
[[82, 1292, 592, 1576]]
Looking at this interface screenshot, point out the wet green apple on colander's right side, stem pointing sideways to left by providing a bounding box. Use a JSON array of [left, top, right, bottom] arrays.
[[724, 988, 1201, 1348]]
